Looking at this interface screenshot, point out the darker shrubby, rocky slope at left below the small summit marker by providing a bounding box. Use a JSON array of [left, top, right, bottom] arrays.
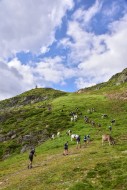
[[0, 88, 68, 158]]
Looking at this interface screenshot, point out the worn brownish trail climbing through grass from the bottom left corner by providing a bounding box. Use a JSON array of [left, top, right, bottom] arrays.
[[0, 145, 87, 189]]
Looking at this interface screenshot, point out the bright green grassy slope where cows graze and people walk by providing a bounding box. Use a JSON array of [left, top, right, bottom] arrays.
[[0, 88, 127, 190]]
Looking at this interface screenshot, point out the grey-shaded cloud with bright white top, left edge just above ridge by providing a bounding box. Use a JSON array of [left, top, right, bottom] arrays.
[[0, 59, 35, 99]]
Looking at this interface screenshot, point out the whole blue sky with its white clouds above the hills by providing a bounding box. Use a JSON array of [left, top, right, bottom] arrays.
[[0, 0, 127, 100]]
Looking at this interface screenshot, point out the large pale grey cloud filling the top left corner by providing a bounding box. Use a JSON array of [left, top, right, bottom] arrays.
[[0, 0, 73, 57]]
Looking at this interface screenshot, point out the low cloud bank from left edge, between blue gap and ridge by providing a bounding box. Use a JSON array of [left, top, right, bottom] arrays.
[[0, 56, 76, 99]]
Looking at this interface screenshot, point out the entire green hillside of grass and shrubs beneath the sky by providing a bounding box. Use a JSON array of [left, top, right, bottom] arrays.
[[0, 69, 127, 190]]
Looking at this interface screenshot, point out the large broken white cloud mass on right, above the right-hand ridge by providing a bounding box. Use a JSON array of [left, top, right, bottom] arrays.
[[61, 1, 127, 88]]
